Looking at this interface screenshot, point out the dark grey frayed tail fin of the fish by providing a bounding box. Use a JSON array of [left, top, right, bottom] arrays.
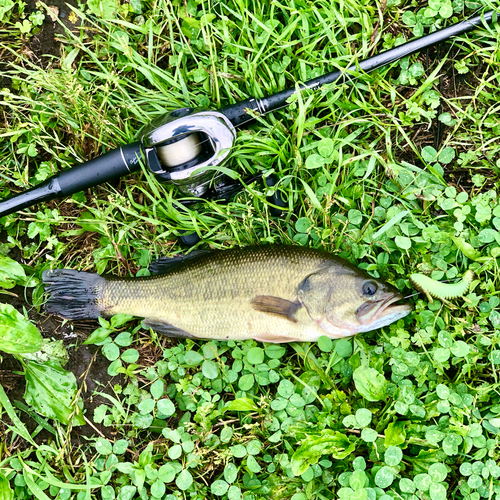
[[42, 269, 106, 319]]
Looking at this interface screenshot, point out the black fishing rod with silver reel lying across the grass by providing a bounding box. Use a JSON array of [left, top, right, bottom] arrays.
[[0, 10, 494, 217]]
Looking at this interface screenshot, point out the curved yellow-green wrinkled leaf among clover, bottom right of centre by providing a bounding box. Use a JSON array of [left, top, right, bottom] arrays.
[[292, 429, 355, 476]]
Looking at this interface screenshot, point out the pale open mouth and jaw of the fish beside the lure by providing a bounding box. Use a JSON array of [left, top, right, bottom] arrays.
[[356, 293, 413, 329]]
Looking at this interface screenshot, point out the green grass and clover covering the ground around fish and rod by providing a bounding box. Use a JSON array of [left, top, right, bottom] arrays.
[[0, 0, 500, 500]]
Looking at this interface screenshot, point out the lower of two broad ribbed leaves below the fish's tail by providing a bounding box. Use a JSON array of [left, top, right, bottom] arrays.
[[24, 361, 84, 425]]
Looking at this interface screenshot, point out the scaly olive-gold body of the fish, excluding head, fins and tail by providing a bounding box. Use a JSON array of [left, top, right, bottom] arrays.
[[101, 247, 325, 340]]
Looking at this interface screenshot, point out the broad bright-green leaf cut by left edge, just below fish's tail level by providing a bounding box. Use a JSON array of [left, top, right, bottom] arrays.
[[0, 304, 42, 354]]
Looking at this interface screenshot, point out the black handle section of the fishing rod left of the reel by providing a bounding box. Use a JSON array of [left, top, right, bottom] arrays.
[[0, 142, 142, 217]]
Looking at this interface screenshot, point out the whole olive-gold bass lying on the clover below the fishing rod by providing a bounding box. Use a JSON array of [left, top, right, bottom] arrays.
[[42, 245, 412, 343]]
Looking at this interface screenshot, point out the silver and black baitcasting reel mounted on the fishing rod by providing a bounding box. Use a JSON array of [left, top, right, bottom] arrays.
[[141, 108, 236, 197]]
